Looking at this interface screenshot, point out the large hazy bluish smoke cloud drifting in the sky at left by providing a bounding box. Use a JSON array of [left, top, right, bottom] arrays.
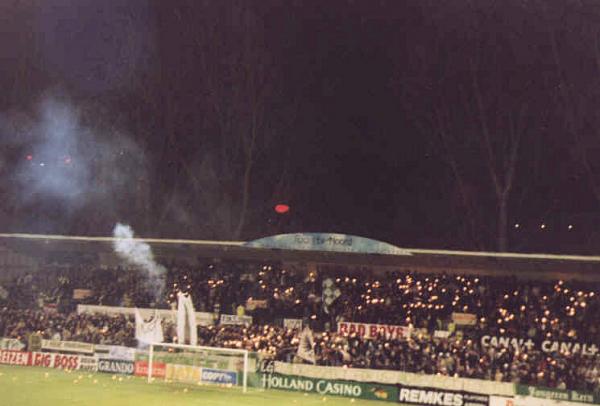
[[0, 90, 147, 234]]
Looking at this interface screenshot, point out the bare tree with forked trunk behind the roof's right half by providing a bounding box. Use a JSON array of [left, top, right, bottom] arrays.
[[397, 1, 548, 251]]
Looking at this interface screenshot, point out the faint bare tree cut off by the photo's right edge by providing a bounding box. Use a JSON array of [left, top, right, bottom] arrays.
[[538, 2, 600, 206]]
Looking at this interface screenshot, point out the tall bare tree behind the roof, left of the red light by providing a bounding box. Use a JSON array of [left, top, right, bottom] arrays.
[[146, 1, 296, 239]]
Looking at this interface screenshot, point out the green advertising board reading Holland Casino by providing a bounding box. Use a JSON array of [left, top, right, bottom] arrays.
[[254, 373, 398, 402]]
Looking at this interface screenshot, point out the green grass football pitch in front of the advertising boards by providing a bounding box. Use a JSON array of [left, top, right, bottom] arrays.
[[0, 365, 389, 406]]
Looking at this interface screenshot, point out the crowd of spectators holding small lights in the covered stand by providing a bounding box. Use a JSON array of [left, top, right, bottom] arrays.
[[0, 262, 600, 390]]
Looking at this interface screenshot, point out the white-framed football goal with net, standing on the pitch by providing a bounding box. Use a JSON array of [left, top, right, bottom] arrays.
[[148, 343, 251, 392]]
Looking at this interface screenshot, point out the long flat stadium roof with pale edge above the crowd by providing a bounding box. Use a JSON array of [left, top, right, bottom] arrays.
[[0, 234, 600, 281]]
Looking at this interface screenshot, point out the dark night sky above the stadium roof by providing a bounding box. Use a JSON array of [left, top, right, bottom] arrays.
[[0, 0, 600, 254]]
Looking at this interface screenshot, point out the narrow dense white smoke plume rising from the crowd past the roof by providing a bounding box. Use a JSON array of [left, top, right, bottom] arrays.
[[113, 223, 166, 302]]
